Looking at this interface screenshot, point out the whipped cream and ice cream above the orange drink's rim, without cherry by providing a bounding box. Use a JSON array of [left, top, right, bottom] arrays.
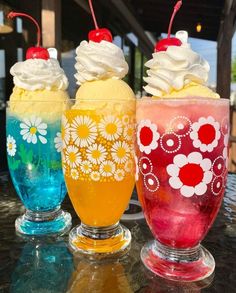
[[74, 41, 134, 107]]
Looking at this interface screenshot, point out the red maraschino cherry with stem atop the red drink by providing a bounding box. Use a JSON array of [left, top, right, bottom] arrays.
[[154, 1, 182, 52]]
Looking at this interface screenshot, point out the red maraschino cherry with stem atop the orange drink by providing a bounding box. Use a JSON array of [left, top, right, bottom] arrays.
[[88, 0, 112, 43]]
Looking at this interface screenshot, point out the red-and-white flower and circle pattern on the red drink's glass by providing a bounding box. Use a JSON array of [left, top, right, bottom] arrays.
[[136, 116, 229, 198]]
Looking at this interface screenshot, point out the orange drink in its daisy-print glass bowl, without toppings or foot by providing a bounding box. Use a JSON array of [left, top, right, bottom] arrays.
[[63, 100, 135, 227]]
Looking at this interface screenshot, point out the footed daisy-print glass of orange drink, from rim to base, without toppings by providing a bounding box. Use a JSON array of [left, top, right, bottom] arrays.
[[62, 99, 135, 256]]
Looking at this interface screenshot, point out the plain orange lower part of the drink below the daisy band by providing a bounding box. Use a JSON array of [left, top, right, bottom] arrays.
[[66, 176, 134, 227]]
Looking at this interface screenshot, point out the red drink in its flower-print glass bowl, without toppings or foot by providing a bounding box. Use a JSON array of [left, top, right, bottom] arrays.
[[137, 98, 229, 280]]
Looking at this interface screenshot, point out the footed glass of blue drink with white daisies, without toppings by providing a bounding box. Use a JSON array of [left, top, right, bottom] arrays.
[[7, 102, 71, 235]]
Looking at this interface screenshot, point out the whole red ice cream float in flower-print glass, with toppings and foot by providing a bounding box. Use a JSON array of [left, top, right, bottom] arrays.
[[136, 2, 229, 281]]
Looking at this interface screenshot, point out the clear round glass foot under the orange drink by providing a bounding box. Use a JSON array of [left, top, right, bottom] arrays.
[[69, 223, 131, 259]]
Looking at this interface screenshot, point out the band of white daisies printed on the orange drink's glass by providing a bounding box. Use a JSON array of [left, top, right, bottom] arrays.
[[62, 111, 135, 182]]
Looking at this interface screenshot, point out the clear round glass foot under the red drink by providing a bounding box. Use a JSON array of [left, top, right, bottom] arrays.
[[141, 240, 215, 282]]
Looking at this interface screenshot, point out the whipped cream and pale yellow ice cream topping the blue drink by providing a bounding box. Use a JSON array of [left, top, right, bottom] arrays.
[[10, 59, 69, 117]]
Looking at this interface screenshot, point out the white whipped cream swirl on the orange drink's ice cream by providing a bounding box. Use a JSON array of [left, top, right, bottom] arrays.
[[75, 41, 129, 85]]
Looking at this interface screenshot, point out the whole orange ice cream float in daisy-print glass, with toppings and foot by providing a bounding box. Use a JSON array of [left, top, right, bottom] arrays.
[[62, 0, 135, 253]]
